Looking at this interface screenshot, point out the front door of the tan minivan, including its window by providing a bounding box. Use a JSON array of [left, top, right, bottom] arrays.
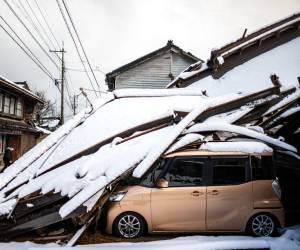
[[151, 157, 206, 232]]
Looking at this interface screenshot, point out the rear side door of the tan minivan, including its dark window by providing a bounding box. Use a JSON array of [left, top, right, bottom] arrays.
[[206, 157, 253, 231]]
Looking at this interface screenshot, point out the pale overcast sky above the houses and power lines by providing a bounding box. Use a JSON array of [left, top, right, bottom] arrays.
[[0, 0, 300, 116]]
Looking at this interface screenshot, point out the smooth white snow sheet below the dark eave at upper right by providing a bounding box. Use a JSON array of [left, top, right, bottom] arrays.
[[187, 37, 300, 96]]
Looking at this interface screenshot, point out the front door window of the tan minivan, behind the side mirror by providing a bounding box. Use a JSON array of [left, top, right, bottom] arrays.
[[165, 158, 204, 187]]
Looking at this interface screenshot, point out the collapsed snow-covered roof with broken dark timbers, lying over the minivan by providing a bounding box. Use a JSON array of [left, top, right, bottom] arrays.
[[0, 82, 300, 242]]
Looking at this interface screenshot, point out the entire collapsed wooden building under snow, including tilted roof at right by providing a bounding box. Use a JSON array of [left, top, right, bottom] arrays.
[[0, 15, 300, 245]]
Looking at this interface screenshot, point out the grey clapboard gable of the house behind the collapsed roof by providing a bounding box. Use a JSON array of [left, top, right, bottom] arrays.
[[106, 40, 201, 90]]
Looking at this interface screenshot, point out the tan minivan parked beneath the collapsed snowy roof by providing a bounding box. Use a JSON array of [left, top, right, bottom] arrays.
[[106, 150, 284, 238]]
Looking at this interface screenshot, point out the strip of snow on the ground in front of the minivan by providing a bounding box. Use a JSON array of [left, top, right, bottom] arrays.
[[0, 225, 300, 250]]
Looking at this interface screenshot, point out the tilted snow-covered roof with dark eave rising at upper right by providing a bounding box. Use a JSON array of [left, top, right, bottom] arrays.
[[167, 13, 300, 93]]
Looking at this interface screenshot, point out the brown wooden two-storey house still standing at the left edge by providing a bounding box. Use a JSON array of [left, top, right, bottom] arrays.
[[0, 77, 43, 169]]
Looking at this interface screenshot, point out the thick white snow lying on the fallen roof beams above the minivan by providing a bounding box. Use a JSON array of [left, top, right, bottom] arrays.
[[0, 86, 296, 240]]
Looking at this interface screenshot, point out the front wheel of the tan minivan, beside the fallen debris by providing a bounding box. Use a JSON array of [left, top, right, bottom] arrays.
[[114, 212, 146, 238]]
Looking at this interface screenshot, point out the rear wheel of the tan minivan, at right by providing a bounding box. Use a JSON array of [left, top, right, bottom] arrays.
[[248, 214, 276, 237]]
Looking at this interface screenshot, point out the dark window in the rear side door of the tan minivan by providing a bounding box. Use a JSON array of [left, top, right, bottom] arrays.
[[212, 158, 246, 185]]
